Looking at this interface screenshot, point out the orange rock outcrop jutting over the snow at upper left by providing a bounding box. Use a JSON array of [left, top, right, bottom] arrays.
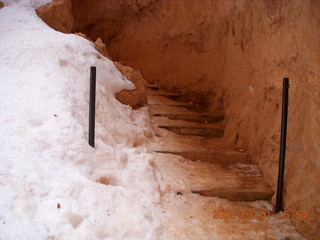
[[37, 0, 73, 33]]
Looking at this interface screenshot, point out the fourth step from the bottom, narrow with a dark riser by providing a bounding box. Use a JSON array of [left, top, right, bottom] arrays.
[[150, 105, 224, 123]]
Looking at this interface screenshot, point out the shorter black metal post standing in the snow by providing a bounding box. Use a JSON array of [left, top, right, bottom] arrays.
[[89, 67, 96, 147]]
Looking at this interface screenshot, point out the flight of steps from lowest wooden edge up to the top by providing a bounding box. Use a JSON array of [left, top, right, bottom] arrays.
[[147, 86, 273, 201]]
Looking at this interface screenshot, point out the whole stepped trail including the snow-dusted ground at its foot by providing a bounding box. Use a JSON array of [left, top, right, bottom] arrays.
[[148, 87, 303, 240]]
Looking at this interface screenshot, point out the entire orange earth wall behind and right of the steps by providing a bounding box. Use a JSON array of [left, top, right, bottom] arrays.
[[38, 0, 320, 239]]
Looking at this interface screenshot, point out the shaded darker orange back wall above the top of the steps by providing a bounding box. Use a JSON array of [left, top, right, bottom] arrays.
[[73, 0, 228, 109]]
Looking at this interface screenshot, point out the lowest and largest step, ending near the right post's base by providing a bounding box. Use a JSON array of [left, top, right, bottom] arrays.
[[153, 154, 273, 201]]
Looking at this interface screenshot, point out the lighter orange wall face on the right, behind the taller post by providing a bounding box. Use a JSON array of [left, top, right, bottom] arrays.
[[221, 0, 320, 239]]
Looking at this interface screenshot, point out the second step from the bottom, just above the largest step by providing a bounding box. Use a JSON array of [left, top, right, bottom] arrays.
[[148, 136, 250, 164]]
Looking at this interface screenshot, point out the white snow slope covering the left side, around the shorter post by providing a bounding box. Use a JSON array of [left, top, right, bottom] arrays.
[[0, 0, 162, 240]]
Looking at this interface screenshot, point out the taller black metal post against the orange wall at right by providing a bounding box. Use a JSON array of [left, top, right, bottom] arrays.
[[276, 78, 289, 212]]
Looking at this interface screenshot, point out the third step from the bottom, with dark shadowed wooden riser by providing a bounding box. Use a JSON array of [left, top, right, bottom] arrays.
[[152, 117, 224, 138]]
